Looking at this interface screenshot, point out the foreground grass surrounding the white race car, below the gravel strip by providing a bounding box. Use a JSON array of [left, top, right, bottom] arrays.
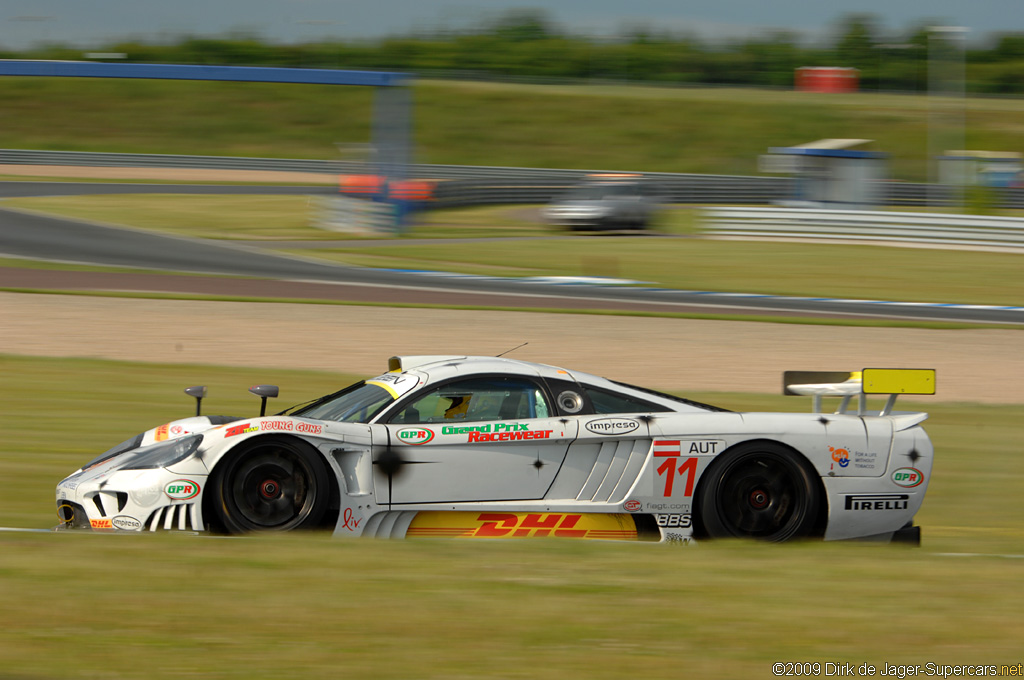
[[0, 356, 1024, 680]]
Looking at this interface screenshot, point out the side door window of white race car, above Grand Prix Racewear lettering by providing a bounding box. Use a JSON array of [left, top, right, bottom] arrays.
[[391, 377, 551, 424]]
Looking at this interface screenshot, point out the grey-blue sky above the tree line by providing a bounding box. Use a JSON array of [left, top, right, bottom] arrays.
[[0, 0, 1024, 49]]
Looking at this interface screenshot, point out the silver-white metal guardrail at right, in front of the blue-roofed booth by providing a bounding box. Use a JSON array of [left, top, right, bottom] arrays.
[[702, 207, 1024, 249]]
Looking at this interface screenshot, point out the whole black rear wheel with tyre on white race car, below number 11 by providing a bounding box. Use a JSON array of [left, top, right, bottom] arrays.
[[694, 441, 821, 542]]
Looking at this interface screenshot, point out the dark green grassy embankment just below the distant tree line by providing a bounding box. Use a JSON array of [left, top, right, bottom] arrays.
[[6, 78, 1024, 181]]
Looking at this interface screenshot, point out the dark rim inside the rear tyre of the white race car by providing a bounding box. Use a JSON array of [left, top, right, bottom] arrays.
[[716, 452, 808, 541]]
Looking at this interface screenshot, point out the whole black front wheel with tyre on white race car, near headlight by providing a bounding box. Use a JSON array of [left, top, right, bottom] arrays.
[[210, 436, 331, 534]]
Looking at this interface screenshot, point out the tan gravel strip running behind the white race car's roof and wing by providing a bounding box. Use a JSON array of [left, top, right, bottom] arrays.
[[0, 293, 1024, 403]]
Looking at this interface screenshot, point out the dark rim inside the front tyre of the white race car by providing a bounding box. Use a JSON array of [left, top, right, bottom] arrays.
[[227, 447, 317, 530]]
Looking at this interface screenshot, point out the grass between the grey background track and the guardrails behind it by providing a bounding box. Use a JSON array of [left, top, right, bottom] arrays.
[[4, 195, 1024, 305]]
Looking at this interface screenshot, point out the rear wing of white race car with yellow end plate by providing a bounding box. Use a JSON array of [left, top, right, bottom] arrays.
[[782, 369, 935, 416]]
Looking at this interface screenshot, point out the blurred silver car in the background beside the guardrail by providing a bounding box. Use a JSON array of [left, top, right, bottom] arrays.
[[544, 174, 657, 230]]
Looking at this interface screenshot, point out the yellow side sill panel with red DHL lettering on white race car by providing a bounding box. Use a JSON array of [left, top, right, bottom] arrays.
[[406, 512, 637, 541]]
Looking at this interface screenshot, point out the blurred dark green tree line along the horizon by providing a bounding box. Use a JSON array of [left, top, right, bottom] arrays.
[[6, 10, 1024, 94]]
